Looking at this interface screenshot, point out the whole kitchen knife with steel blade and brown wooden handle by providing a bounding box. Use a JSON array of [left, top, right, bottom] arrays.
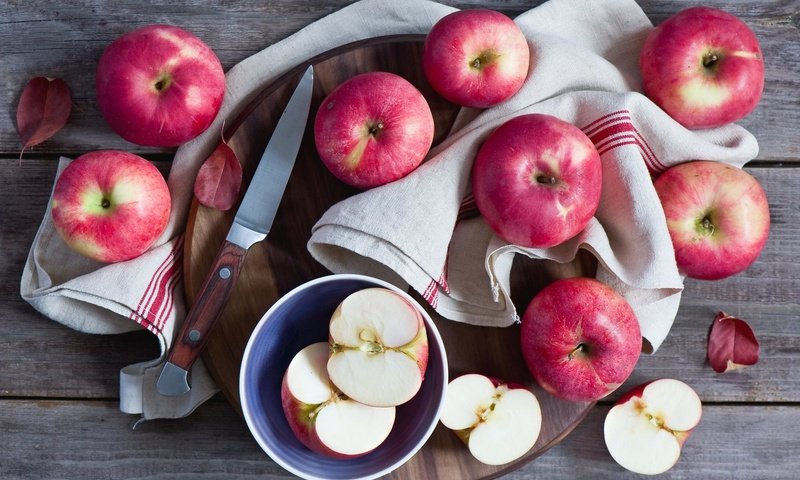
[[156, 66, 314, 396]]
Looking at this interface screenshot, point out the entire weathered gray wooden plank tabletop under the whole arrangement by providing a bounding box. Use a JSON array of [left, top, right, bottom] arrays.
[[0, 0, 800, 480]]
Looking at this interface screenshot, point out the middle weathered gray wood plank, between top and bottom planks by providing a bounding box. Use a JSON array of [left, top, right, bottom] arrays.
[[0, 162, 800, 402]]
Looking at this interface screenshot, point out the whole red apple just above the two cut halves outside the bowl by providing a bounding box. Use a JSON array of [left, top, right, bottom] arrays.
[[520, 278, 642, 402]]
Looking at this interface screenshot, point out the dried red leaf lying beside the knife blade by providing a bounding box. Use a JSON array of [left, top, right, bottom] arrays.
[[194, 142, 242, 211]]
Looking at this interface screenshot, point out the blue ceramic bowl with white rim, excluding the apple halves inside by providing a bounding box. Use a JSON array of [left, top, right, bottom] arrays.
[[239, 275, 448, 480]]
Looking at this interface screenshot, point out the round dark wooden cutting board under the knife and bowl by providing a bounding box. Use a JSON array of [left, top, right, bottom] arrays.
[[185, 36, 593, 479]]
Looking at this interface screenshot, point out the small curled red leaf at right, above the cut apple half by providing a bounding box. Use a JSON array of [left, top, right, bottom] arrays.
[[708, 312, 760, 373]]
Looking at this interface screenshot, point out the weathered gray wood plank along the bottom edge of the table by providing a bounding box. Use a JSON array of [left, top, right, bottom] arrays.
[[0, 397, 800, 480]]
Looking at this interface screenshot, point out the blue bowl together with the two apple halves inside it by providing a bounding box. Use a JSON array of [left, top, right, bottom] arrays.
[[239, 274, 448, 479]]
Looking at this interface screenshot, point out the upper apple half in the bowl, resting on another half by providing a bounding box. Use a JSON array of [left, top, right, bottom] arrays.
[[328, 287, 428, 407]]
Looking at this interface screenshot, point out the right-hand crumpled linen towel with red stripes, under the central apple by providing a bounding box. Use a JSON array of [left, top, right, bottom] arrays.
[[308, 0, 758, 353]]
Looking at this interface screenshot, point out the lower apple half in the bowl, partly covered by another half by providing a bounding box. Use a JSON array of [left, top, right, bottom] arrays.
[[281, 342, 395, 458]]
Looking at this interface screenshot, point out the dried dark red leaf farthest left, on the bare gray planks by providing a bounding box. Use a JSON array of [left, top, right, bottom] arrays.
[[17, 77, 72, 150]]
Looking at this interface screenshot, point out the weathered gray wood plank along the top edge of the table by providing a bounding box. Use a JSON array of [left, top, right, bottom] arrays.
[[0, 0, 800, 162]]
